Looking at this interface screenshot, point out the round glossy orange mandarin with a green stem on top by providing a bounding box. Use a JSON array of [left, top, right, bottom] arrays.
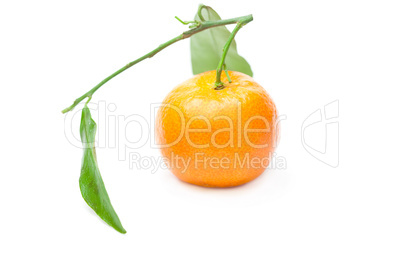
[[155, 71, 279, 187]]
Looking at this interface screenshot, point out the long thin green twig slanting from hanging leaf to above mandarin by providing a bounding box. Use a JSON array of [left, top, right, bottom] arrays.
[[62, 15, 253, 114]]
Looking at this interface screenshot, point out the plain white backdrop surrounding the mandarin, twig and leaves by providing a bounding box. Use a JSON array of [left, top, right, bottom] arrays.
[[0, 0, 402, 267]]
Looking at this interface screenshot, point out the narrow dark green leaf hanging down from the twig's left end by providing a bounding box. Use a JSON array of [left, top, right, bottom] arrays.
[[80, 105, 126, 234]]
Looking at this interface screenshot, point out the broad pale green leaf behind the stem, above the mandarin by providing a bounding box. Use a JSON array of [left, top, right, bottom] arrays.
[[190, 6, 253, 76]]
